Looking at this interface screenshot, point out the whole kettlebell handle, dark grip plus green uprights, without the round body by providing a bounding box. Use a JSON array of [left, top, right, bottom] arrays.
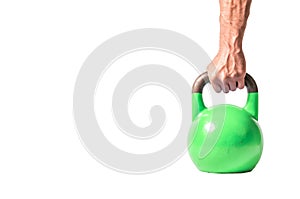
[[192, 72, 258, 120]]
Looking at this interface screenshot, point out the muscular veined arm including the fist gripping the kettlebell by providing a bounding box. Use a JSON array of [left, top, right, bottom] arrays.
[[207, 0, 251, 93]]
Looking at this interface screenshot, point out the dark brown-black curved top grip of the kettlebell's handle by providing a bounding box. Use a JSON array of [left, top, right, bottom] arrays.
[[192, 72, 258, 93]]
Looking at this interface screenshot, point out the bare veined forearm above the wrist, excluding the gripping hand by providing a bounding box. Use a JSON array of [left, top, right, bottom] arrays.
[[220, 0, 251, 53]]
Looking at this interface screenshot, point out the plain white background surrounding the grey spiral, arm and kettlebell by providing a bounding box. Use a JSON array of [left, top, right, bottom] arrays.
[[0, 0, 300, 198]]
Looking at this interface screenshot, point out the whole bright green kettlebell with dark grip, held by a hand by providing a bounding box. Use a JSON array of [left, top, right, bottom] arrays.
[[188, 72, 263, 173]]
